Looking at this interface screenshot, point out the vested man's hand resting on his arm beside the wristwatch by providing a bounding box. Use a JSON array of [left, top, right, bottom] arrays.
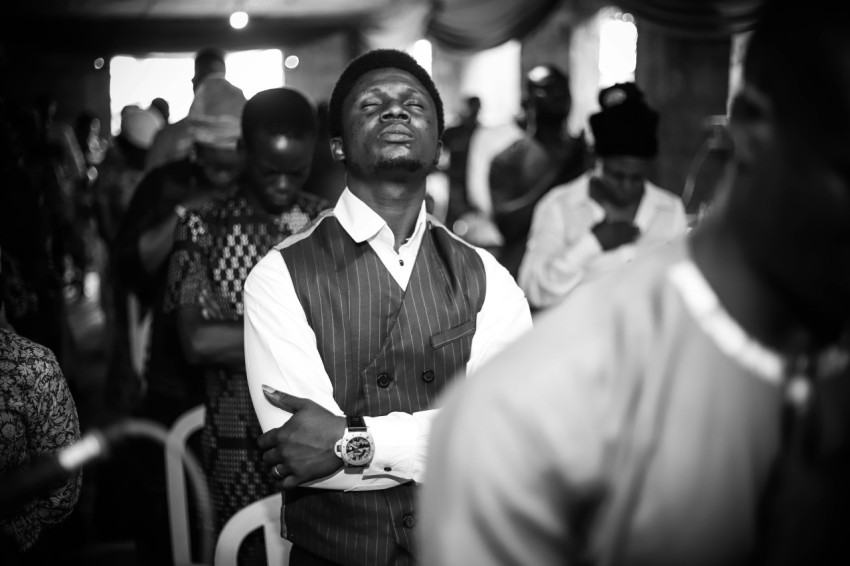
[[257, 386, 345, 489]]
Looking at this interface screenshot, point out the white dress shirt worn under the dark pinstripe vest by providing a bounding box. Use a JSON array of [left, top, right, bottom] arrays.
[[244, 189, 531, 490]]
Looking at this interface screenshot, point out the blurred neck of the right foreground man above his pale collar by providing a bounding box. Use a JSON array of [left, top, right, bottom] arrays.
[[689, 215, 815, 355]]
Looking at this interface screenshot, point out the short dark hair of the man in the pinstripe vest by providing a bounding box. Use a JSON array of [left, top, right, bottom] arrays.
[[328, 49, 445, 137]]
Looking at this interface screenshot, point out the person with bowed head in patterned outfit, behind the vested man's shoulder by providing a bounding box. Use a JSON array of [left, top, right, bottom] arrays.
[[163, 88, 326, 566]]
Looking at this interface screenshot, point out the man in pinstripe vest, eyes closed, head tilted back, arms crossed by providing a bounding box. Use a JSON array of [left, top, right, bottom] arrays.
[[244, 50, 531, 566]]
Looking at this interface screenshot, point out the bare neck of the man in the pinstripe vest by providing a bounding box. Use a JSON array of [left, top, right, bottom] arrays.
[[348, 175, 425, 251]]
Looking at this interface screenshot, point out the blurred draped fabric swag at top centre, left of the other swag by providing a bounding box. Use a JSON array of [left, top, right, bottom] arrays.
[[428, 0, 560, 52]]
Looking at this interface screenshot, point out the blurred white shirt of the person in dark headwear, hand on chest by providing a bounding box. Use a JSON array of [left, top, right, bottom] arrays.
[[518, 172, 688, 308]]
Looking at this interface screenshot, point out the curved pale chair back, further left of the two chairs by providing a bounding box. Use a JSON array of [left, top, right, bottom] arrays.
[[165, 405, 206, 566]]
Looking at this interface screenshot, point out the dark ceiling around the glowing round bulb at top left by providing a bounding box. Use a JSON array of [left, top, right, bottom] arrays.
[[0, 0, 400, 54]]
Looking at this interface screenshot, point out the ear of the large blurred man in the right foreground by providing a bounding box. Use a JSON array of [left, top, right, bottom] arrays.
[[729, 85, 774, 163]]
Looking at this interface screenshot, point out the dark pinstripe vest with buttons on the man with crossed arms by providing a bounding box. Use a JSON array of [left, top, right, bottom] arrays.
[[281, 213, 486, 566]]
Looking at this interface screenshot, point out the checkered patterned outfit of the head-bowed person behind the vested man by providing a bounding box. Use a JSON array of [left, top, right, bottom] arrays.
[[164, 192, 326, 566]]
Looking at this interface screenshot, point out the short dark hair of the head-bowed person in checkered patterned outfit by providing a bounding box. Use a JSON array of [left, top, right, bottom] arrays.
[[242, 87, 319, 144]]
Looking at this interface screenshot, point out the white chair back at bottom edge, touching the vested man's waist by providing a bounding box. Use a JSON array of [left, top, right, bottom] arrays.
[[213, 493, 292, 566]]
